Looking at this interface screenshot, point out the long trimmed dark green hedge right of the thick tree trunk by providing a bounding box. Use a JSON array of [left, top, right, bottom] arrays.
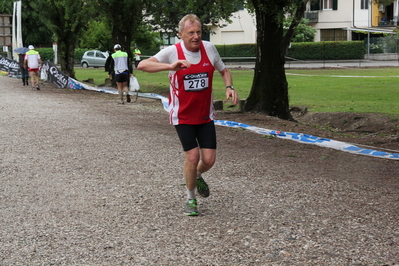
[[287, 41, 365, 60]]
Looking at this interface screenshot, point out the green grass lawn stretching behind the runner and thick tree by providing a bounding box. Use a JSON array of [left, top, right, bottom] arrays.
[[75, 68, 399, 116]]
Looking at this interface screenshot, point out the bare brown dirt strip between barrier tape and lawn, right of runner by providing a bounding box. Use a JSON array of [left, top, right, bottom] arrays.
[[217, 108, 399, 153]]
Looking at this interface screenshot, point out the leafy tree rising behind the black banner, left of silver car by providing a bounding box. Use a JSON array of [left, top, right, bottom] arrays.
[[30, 0, 94, 78]]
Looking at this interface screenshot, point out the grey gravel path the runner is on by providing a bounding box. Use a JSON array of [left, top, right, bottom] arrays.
[[0, 76, 399, 265]]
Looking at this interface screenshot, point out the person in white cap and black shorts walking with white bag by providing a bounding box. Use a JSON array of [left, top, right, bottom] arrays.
[[108, 44, 133, 104]]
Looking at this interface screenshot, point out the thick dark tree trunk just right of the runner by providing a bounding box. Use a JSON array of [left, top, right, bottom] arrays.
[[244, 1, 292, 120]]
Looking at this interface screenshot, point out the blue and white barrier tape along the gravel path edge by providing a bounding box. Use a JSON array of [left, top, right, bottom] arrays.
[[68, 78, 399, 160]]
